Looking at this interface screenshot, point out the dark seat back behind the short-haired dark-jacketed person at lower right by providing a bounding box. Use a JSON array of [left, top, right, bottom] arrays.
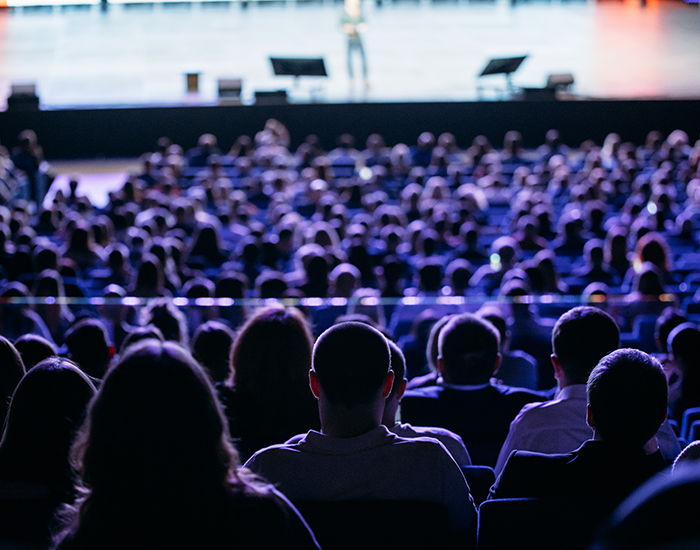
[[477, 498, 617, 550]]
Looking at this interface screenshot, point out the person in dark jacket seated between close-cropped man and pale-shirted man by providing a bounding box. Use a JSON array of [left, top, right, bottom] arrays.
[[401, 313, 543, 467]]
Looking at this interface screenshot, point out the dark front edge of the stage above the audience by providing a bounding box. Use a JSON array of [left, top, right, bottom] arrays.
[[0, 99, 700, 160]]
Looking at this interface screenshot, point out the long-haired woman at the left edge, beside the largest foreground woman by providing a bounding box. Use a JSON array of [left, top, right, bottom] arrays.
[[0, 357, 95, 548]]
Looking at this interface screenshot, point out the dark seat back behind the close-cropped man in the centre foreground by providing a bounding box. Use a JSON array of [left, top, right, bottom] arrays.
[[294, 500, 450, 550]]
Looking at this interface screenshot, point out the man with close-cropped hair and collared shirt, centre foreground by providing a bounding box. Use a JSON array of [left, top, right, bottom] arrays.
[[246, 322, 476, 533]]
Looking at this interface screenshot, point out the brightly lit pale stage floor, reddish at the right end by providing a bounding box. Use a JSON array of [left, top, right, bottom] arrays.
[[0, 0, 700, 109]]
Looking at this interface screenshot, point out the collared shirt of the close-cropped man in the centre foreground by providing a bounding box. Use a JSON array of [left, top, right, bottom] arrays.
[[245, 426, 476, 532]]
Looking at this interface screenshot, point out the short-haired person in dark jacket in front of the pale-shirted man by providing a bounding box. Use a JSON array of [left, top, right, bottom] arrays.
[[489, 349, 667, 503]]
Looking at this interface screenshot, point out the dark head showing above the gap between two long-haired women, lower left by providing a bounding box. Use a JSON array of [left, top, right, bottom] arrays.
[[66, 319, 114, 379]]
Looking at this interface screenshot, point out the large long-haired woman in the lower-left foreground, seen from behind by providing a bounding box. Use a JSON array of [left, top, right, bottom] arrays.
[[56, 340, 317, 550]]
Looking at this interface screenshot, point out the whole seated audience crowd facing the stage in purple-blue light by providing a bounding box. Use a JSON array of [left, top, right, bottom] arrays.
[[0, 120, 700, 549]]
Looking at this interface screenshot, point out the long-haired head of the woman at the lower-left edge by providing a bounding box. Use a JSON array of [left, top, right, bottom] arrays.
[[0, 357, 95, 491]]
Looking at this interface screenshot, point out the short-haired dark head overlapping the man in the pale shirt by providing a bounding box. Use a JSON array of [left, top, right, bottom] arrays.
[[586, 348, 668, 447]]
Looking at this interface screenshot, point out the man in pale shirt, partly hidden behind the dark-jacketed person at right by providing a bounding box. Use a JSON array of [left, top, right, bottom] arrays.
[[494, 306, 680, 476]]
